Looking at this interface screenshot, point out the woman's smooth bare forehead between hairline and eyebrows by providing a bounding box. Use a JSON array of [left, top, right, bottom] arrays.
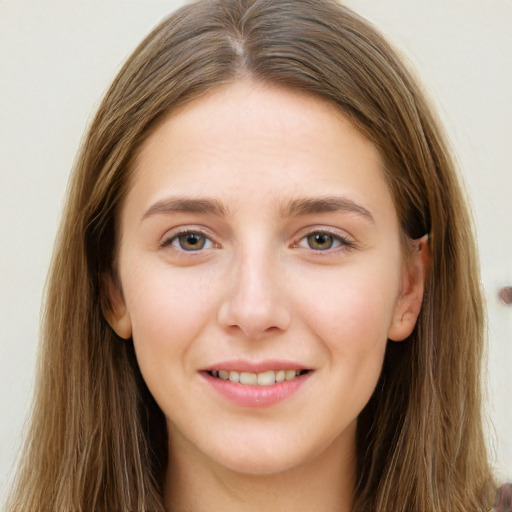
[[128, 81, 391, 222]]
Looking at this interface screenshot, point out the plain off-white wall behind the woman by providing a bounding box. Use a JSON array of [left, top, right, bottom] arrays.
[[0, 0, 512, 503]]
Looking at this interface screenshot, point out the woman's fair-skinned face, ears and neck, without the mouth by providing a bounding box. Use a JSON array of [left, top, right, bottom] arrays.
[[108, 81, 427, 512]]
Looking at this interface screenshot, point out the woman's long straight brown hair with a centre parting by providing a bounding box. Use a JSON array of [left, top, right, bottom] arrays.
[[7, 0, 494, 512]]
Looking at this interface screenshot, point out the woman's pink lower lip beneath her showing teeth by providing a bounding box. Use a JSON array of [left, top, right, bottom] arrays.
[[201, 372, 313, 407]]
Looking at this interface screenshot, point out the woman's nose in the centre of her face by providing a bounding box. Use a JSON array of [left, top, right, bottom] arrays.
[[218, 245, 291, 339]]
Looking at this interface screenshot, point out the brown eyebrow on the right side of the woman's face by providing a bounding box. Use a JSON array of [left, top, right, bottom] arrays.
[[283, 196, 375, 223]]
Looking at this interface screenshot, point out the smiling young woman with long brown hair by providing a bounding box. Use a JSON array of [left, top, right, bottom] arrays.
[[4, 0, 508, 512]]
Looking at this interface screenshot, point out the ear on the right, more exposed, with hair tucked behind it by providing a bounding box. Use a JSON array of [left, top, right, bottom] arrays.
[[388, 235, 430, 341]]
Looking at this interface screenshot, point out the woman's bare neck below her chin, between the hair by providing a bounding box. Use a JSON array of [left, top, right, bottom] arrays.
[[165, 428, 355, 512]]
